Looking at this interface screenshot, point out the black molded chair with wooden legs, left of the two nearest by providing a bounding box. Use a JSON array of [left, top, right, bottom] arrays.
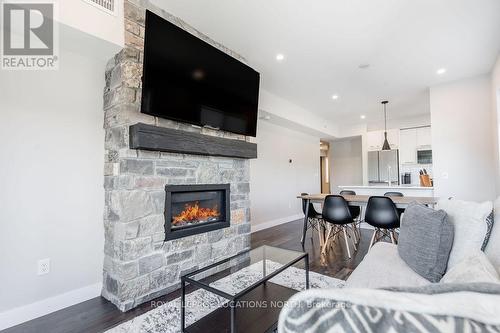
[[321, 195, 357, 258]]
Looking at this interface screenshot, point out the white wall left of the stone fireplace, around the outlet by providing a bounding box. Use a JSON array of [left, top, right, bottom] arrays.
[[0, 44, 105, 330]]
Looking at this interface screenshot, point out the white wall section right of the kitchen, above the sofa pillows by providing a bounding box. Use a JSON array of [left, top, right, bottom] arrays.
[[430, 75, 496, 201]]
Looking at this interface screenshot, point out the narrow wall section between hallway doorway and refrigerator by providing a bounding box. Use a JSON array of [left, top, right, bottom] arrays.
[[329, 136, 363, 193]]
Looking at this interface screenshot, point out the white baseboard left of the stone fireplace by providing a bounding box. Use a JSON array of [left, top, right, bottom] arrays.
[[0, 283, 102, 331]]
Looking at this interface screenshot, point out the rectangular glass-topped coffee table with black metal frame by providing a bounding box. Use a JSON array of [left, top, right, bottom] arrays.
[[181, 245, 309, 333]]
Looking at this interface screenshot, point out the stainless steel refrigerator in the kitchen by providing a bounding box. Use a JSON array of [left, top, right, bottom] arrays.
[[368, 149, 399, 185]]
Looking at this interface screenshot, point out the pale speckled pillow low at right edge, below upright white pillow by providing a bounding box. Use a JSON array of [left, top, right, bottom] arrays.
[[440, 251, 500, 283]]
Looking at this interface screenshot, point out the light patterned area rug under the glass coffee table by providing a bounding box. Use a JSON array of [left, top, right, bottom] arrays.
[[106, 261, 345, 333]]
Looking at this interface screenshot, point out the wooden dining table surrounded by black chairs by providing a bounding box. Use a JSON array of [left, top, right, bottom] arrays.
[[297, 193, 439, 247]]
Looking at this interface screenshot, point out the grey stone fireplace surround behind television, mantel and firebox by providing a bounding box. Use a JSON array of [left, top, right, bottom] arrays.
[[102, 0, 250, 311]]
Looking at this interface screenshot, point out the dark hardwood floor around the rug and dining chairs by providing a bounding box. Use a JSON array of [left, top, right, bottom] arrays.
[[2, 220, 370, 333]]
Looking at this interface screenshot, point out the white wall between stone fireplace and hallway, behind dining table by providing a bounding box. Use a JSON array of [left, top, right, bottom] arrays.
[[250, 120, 320, 231]]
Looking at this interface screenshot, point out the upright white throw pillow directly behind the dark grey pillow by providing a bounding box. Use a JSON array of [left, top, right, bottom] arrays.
[[436, 199, 493, 271]]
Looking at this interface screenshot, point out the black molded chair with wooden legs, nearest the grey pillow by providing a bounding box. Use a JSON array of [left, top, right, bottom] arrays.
[[365, 196, 400, 248]]
